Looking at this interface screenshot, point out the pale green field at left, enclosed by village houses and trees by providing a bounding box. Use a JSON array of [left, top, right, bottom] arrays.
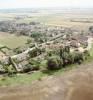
[[0, 32, 28, 49]]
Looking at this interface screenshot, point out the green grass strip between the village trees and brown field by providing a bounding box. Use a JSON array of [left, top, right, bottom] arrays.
[[0, 65, 77, 86]]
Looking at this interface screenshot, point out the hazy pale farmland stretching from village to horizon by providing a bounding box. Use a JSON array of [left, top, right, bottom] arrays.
[[0, 9, 93, 30]]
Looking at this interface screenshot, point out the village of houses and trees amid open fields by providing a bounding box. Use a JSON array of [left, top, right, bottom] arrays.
[[0, 21, 93, 72]]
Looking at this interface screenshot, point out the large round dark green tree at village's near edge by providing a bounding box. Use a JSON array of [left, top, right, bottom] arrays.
[[47, 56, 63, 70]]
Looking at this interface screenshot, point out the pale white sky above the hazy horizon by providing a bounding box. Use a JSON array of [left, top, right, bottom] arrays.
[[0, 0, 93, 9]]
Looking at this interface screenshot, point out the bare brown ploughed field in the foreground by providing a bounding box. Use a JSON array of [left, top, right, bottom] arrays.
[[0, 63, 93, 100]]
